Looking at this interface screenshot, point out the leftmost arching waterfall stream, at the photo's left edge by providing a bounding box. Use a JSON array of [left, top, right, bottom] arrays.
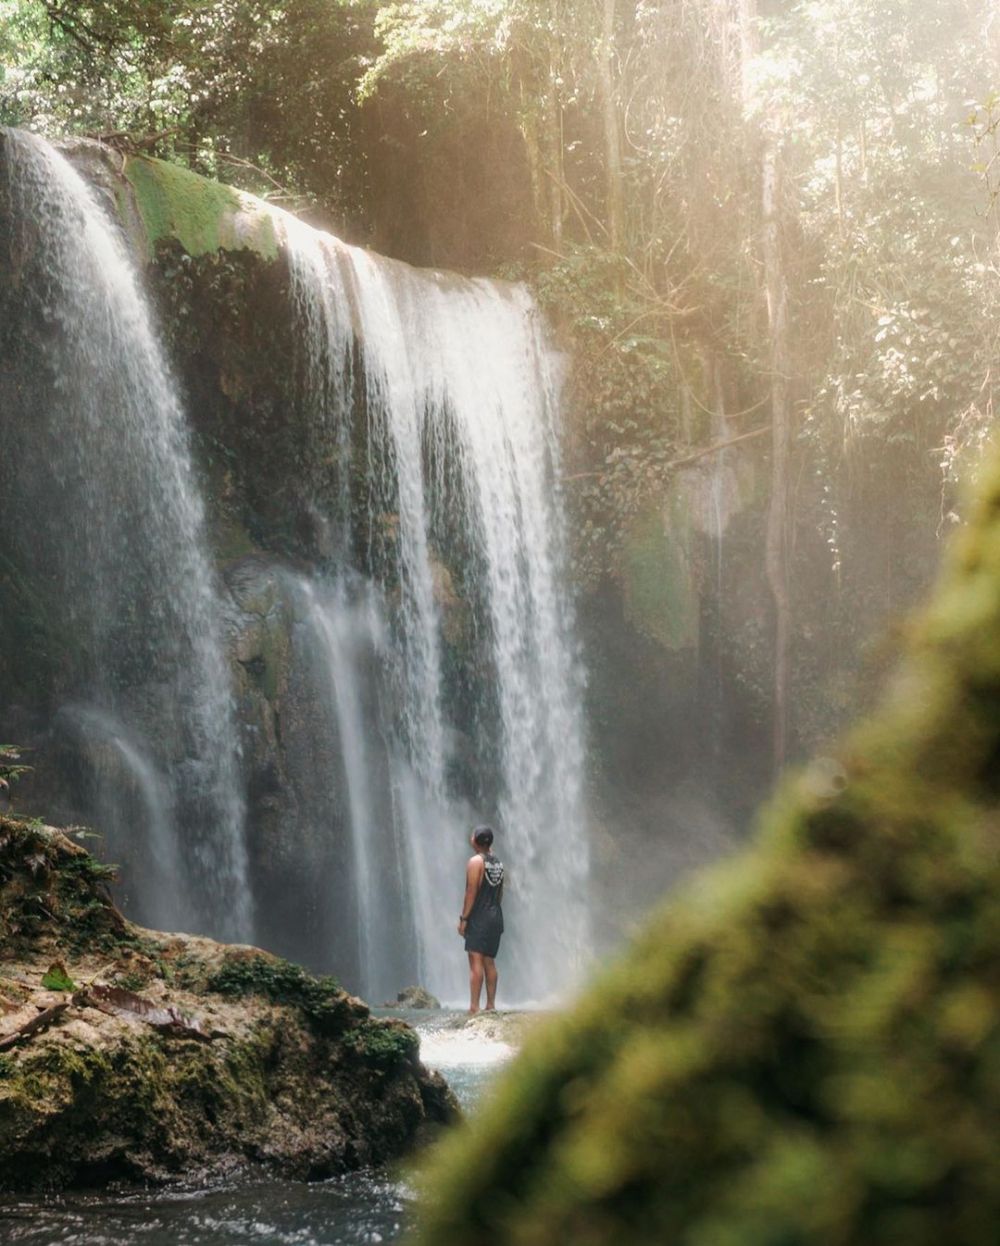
[[4, 131, 250, 937]]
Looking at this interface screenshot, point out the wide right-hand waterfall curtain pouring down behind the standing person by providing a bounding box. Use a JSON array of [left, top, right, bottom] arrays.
[[275, 213, 589, 999]]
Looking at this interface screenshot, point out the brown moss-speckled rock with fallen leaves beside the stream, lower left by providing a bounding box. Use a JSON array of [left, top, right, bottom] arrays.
[[0, 817, 456, 1192]]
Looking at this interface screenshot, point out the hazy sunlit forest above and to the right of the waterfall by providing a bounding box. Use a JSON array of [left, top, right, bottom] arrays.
[[0, 0, 1000, 897]]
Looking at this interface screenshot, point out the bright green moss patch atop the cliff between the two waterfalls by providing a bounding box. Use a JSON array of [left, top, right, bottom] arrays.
[[125, 157, 278, 259]]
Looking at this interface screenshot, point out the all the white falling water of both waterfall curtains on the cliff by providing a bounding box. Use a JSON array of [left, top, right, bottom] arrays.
[[0, 132, 589, 1002]]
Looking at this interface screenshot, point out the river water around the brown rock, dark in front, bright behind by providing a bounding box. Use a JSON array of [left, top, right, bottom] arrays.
[[0, 1012, 513, 1246]]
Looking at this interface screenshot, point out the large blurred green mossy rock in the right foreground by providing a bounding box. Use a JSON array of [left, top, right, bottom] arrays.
[[420, 441, 1000, 1246]]
